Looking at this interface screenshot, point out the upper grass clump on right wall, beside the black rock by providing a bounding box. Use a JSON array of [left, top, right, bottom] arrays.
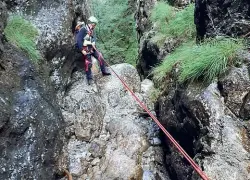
[[151, 2, 195, 46]]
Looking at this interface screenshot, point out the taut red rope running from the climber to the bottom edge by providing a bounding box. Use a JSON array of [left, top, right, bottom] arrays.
[[104, 61, 209, 180]]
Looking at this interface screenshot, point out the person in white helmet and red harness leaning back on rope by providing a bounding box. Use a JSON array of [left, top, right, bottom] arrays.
[[75, 16, 111, 85]]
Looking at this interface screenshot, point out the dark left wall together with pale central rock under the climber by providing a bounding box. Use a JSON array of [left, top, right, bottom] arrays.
[[0, 0, 169, 180]]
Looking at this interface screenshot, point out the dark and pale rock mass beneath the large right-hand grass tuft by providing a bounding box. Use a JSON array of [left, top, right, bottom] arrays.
[[158, 66, 250, 180]]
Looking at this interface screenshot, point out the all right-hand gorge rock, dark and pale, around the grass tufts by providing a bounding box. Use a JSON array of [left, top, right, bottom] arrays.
[[136, 0, 250, 180]]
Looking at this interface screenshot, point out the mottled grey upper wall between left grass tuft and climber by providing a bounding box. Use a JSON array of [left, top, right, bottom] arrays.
[[6, 0, 90, 94]]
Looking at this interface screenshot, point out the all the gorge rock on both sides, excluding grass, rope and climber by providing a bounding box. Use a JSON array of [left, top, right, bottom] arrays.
[[0, 0, 250, 180]]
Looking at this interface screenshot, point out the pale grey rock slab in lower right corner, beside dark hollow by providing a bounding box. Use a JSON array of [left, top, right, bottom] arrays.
[[202, 84, 250, 180]]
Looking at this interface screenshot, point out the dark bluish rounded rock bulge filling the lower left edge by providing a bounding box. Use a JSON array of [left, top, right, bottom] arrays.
[[0, 2, 65, 180]]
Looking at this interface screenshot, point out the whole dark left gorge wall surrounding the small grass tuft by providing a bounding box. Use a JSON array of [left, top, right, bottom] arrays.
[[0, 0, 91, 180]]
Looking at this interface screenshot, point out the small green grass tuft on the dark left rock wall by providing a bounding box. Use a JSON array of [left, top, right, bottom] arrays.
[[4, 16, 41, 61]]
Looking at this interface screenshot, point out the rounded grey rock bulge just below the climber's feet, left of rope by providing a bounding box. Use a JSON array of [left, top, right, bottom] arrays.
[[63, 72, 105, 141]]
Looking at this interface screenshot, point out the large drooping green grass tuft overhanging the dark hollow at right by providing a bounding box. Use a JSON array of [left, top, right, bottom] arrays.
[[153, 38, 244, 83]]
